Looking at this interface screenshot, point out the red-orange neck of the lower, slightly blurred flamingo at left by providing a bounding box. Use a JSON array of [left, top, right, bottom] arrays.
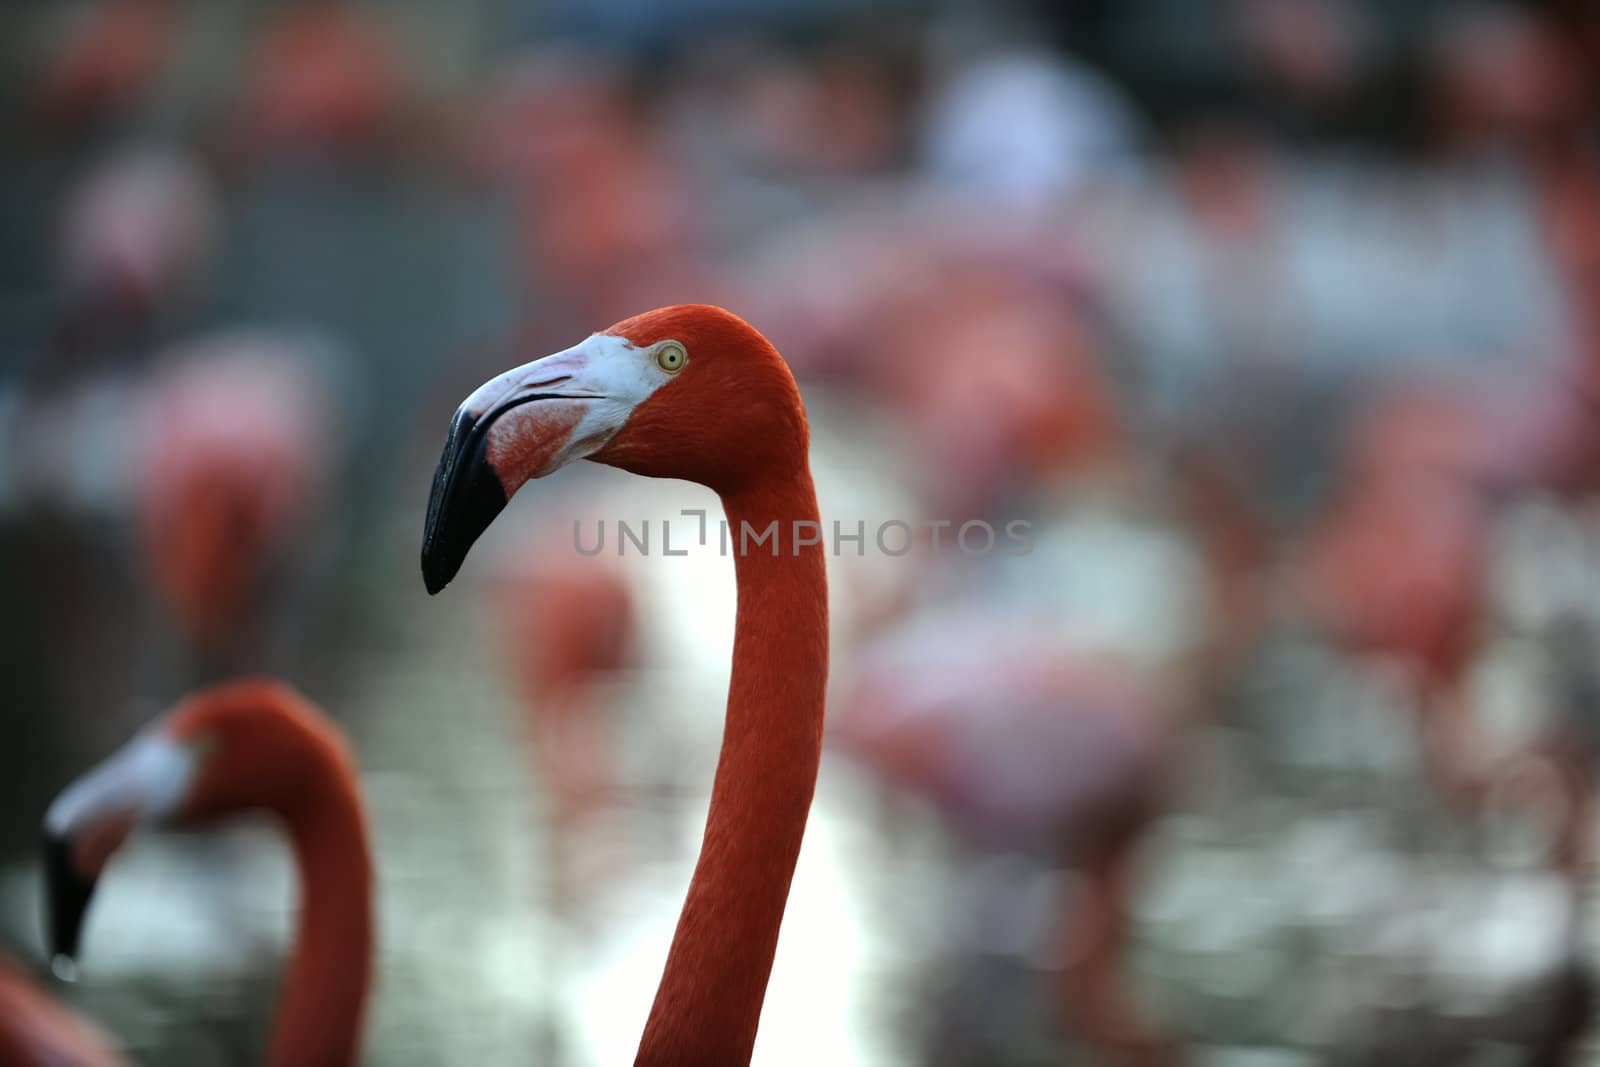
[[267, 758, 373, 1067]]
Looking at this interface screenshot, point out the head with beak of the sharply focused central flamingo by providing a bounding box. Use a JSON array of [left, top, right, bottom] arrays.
[[422, 304, 808, 593]]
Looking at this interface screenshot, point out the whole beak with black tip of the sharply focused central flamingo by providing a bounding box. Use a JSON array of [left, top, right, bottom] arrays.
[[422, 334, 634, 593]]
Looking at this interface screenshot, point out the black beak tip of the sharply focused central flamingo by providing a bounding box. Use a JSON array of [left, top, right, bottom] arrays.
[[422, 406, 506, 593]]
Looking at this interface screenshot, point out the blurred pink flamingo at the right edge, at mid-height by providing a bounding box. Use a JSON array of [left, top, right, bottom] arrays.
[[1296, 373, 1597, 800]]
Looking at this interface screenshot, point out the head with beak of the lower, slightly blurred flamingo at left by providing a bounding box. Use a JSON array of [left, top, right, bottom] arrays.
[[45, 681, 354, 960]]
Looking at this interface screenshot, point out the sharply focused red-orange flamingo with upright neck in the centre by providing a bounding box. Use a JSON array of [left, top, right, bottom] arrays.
[[422, 304, 827, 1067]]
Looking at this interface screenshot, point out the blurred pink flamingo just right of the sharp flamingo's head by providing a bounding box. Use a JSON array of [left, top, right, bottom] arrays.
[[744, 228, 1130, 518]]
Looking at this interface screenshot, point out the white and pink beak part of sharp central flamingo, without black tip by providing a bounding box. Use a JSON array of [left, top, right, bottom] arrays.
[[462, 333, 693, 493]]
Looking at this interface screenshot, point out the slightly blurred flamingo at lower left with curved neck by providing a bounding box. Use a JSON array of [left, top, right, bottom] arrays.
[[42, 680, 373, 1067]]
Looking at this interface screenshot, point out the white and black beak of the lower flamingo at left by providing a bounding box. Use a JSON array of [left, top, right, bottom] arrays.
[[45, 731, 198, 961]]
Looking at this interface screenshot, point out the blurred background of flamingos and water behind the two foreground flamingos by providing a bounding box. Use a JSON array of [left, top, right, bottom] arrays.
[[0, 0, 1600, 1067]]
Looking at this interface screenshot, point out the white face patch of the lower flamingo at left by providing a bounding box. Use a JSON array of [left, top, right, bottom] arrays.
[[45, 729, 198, 837]]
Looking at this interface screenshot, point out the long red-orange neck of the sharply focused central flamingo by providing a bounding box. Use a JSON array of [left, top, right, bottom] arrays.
[[637, 464, 827, 1067]]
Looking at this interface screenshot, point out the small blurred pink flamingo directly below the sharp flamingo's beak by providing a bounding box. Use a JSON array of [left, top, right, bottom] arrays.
[[494, 536, 635, 907]]
